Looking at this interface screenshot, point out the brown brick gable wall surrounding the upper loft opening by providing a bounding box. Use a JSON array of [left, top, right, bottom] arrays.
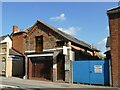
[[25, 25, 62, 51]]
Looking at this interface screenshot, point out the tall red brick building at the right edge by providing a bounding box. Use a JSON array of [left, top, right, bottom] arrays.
[[107, 6, 120, 87]]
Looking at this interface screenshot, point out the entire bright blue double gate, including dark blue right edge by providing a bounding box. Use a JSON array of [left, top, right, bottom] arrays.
[[73, 60, 109, 85]]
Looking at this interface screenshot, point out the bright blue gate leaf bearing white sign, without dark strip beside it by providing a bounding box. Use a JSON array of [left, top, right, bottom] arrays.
[[90, 60, 104, 85]]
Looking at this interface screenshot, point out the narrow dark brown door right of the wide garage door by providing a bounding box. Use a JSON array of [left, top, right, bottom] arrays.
[[57, 54, 65, 80]]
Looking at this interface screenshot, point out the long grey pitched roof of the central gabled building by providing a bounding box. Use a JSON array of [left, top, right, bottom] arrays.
[[26, 20, 100, 52]]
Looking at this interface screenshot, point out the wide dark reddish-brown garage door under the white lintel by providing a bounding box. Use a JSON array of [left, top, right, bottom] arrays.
[[32, 57, 53, 80]]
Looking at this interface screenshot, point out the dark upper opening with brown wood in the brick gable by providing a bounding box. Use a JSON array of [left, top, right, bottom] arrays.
[[35, 36, 43, 52]]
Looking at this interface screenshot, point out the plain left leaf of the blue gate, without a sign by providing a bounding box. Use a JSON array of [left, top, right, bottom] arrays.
[[73, 61, 89, 83]]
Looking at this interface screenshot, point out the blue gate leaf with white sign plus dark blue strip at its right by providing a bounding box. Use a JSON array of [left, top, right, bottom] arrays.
[[90, 60, 109, 85]]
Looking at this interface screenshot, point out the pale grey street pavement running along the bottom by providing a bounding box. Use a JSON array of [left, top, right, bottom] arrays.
[[0, 77, 120, 90]]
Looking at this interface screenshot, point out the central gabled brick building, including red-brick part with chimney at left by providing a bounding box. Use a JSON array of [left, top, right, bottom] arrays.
[[11, 20, 99, 82]]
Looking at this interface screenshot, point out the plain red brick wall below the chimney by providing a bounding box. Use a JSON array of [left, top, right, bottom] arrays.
[[12, 33, 24, 54]]
